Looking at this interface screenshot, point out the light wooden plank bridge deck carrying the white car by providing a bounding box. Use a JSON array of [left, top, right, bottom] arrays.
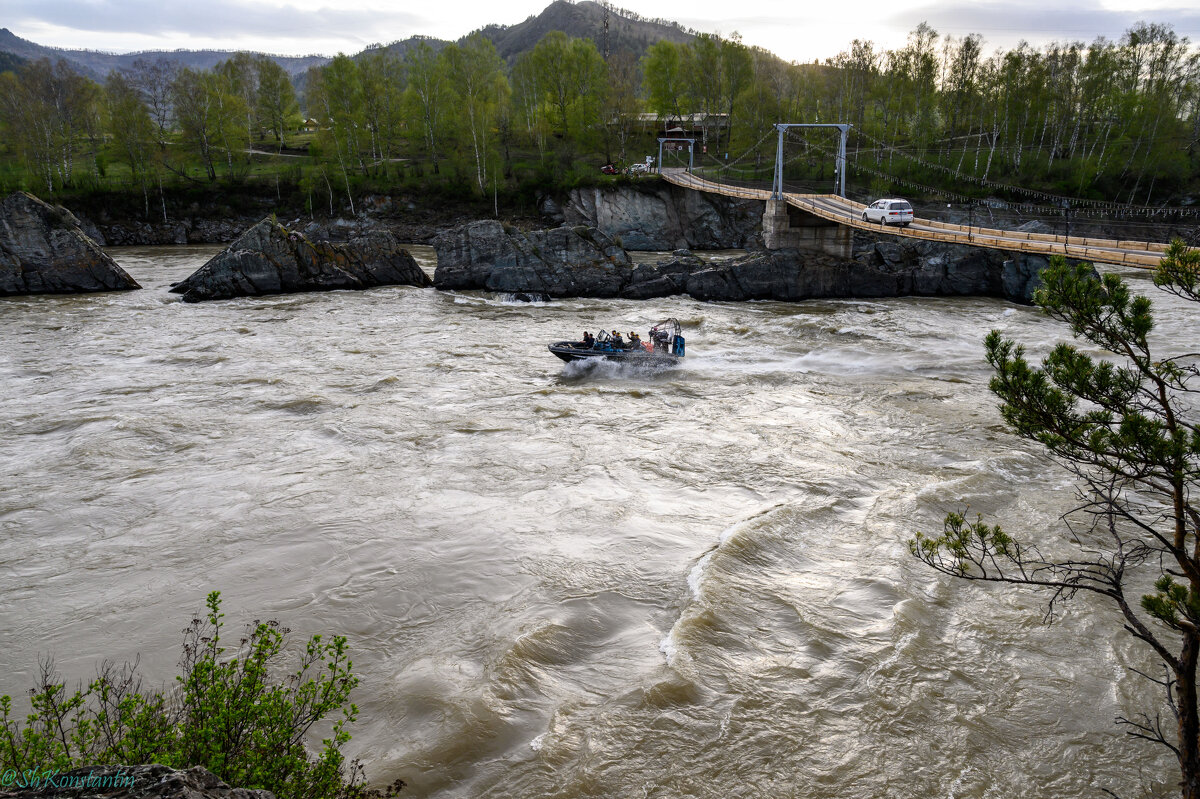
[[662, 169, 1166, 269]]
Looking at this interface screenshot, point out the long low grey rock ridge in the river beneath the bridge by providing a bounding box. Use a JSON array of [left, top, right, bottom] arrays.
[[434, 222, 1046, 302]]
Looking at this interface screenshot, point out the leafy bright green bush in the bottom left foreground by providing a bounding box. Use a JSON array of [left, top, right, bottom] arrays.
[[0, 591, 386, 799]]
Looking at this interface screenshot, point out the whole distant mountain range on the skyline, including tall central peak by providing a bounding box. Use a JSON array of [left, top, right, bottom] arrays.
[[0, 0, 695, 80]]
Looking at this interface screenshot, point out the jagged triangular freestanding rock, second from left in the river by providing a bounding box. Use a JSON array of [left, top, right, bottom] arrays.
[[170, 220, 431, 302]]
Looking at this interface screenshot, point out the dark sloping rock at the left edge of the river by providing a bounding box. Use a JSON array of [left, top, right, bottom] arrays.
[[0, 192, 142, 296]]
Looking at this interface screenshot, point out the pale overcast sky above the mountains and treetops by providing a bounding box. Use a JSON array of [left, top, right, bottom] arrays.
[[0, 0, 1200, 61]]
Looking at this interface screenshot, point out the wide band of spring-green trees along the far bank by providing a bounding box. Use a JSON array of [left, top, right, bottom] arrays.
[[0, 24, 1200, 204]]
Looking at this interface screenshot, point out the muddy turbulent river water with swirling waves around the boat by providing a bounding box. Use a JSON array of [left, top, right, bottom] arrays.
[[0, 247, 1185, 799]]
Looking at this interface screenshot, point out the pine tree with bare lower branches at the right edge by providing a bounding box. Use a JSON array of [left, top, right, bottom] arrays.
[[910, 241, 1200, 799]]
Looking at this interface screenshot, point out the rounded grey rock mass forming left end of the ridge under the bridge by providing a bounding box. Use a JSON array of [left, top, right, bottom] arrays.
[[433, 221, 632, 296]]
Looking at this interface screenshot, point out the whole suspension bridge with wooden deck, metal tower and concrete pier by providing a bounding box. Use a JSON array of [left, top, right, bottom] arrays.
[[659, 124, 1190, 269]]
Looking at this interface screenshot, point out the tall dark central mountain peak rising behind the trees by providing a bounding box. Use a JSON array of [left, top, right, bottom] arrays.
[[479, 0, 696, 62]]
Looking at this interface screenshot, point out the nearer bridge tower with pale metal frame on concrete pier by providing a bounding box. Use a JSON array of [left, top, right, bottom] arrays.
[[762, 122, 853, 259]]
